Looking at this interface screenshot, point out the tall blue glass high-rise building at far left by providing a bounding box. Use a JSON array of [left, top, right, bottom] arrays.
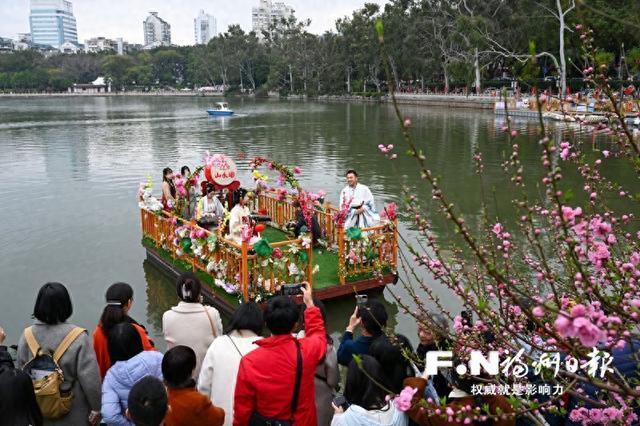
[[29, 0, 78, 48]]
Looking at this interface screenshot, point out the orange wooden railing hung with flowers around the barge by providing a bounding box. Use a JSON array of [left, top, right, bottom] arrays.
[[140, 192, 398, 300]]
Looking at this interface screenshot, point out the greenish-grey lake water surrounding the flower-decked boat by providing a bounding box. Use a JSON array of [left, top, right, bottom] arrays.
[[0, 97, 633, 346]]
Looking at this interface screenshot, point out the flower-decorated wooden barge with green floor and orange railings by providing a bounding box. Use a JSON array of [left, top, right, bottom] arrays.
[[140, 191, 398, 313]]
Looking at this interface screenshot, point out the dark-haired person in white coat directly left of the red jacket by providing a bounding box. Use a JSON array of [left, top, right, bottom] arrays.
[[198, 302, 264, 426]]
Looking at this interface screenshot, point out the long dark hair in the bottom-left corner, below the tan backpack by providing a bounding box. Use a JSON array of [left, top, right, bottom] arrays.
[[0, 367, 42, 426]]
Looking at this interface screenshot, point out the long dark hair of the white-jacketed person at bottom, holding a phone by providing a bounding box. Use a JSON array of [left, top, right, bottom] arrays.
[[344, 355, 387, 410]]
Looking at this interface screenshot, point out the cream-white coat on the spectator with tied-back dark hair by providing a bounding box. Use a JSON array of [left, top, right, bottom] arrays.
[[162, 302, 222, 380]]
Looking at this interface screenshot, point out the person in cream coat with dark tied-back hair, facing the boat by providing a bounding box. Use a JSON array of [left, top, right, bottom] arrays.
[[162, 272, 222, 380]]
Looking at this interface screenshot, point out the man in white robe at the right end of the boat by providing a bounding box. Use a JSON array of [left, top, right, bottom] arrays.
[[340, 170, 380, 228]]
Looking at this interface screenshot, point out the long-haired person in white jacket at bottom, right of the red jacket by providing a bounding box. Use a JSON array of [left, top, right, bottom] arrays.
[[331, 355, 409, 426]]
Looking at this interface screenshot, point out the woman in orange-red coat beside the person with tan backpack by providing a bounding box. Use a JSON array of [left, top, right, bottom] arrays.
[[93, 283, 155, 379]]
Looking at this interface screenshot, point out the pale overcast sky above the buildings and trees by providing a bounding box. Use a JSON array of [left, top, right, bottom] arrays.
[[0, 0, 387, 45]]
